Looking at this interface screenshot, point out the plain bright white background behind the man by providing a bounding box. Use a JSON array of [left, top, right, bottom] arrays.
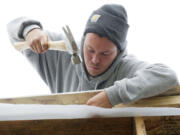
[[0, 0, 180, 98]]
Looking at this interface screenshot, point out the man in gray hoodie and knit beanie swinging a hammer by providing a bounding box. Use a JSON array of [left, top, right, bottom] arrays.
[[8, 4, 178, 108]]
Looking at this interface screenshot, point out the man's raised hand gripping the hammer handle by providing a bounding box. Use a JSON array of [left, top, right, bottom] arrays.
[[26, 29, 49, 53]]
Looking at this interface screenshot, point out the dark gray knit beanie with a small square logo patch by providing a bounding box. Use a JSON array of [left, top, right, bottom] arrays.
[[84, 4, 129, 51]]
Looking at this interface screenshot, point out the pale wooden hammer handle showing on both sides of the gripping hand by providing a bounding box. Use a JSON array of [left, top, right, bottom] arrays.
[[14, 40, 67, 51]]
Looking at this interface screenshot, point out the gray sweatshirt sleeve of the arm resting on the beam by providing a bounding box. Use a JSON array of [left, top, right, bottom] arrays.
[[106, 55, 179, 105]]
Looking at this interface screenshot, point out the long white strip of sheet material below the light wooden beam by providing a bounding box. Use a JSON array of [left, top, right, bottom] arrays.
[[0, 103, 180, 121]]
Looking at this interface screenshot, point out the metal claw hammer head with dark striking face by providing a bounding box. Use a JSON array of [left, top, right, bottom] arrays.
[[63, 26, 82, 64]]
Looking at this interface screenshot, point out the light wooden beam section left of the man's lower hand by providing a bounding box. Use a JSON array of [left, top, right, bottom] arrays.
[[0, 90, 101, 105]]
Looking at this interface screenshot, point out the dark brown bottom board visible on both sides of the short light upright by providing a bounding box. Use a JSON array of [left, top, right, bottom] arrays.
[[0, 116, 180, 135]]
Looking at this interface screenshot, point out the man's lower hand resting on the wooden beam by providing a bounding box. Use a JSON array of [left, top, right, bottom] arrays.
[[86, 91, 112, 108]]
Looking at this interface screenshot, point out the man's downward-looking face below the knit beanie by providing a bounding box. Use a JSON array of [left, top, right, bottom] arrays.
[[83, 33, 119, 77]]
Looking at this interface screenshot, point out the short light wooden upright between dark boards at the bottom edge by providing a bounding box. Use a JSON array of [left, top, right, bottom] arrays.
[[134, 117, 147, 135]]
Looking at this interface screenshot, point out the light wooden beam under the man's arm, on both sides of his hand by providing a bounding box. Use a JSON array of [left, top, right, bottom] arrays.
[[0, 86, 180, 107]]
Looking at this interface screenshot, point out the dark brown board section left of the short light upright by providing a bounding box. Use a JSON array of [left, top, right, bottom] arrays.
[[0, 118, 133, 135]]
